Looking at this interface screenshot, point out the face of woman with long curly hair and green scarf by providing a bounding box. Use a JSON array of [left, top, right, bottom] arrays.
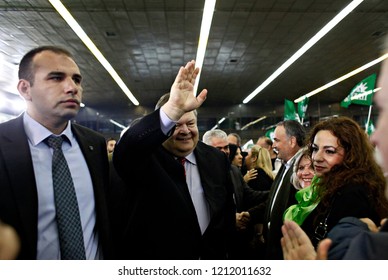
[[311, 130, 345, 177]]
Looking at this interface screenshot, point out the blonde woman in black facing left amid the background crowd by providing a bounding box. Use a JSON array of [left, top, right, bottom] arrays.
[[244, 145, 275, 191]]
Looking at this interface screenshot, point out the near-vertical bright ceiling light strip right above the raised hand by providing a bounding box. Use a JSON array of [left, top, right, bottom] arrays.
[[194, 0, 216, 95]]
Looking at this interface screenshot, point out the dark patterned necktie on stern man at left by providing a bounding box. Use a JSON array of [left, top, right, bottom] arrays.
[[46, 135, 86, 260]]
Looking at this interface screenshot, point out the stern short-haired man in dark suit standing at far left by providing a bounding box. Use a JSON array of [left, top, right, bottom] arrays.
[[0, 46, 112, 259]]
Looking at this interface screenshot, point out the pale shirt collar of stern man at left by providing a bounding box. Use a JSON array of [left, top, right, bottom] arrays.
[[23, 112, 73, 146]]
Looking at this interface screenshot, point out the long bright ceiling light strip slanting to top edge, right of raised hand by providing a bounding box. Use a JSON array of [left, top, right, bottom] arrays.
[[243, 0, 363, 104]]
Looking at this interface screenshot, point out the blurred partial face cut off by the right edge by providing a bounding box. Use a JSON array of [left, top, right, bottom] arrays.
[[371, 61, 388, 173]]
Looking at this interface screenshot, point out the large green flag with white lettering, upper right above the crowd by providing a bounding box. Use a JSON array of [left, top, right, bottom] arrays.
[[341, 74, 376, 108]]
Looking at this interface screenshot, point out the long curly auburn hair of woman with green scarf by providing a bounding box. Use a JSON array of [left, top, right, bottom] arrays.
[[307, 117, 388, 218]]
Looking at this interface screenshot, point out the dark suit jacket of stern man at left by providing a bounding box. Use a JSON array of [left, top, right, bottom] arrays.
[[0, 116, 112, 259]]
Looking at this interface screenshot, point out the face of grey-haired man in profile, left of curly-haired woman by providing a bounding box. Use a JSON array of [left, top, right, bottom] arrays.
[[273, 125, 296, 161]]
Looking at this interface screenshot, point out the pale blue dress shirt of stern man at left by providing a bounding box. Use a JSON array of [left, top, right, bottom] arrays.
[[23, 113, 99, 260]]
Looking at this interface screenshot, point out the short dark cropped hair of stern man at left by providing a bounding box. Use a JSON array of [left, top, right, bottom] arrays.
[[18, 46, 74, 85]]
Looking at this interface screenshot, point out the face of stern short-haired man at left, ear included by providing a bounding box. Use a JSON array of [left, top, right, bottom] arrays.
[[18, 51, 82, 125]]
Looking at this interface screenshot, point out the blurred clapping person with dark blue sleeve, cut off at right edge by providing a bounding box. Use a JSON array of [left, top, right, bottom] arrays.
[[281, 93, 388, 260]]
